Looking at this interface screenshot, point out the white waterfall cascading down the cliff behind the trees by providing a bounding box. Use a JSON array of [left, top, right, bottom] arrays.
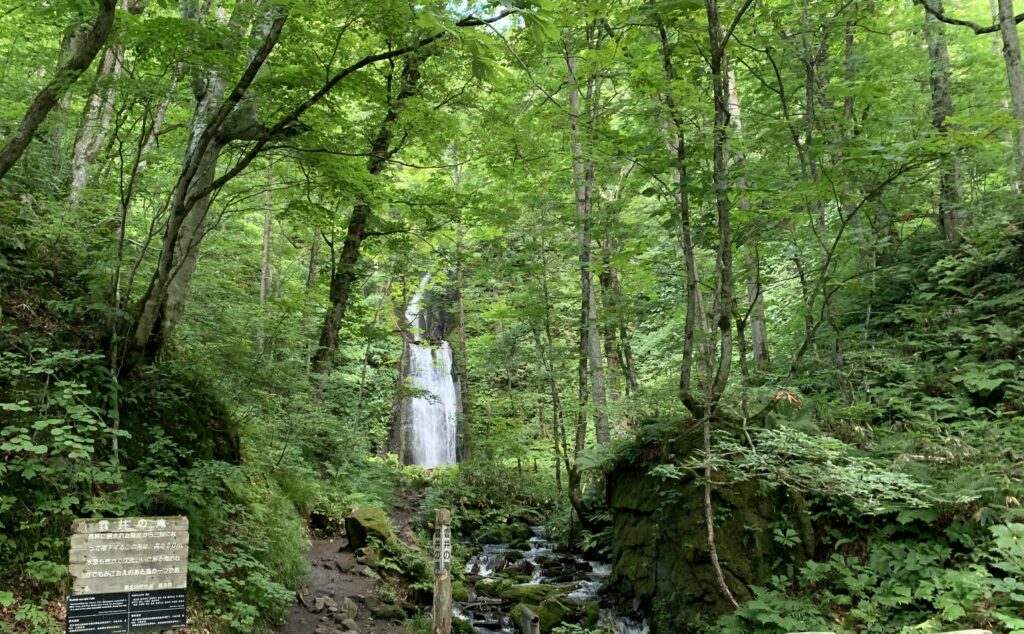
[[406, 273, 459, 469]]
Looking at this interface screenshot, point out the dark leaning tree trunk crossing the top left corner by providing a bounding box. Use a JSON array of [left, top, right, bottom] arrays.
[[0, 0, 117, 179]]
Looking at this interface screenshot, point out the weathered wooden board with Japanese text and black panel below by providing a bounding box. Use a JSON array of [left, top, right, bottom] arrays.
[[66, 517, 188, 634]]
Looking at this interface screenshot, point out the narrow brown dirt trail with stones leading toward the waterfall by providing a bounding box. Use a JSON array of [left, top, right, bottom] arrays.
[[280, 489, 423, 634]]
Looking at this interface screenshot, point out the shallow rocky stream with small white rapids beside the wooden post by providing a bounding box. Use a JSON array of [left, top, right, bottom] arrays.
[[456, 526, 649, 634]]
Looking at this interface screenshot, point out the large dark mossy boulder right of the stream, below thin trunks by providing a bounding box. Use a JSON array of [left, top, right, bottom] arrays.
[[607, 428, 782, 634]]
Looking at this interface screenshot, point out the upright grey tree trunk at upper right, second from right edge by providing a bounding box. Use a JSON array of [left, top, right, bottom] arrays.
[[925, 0, 964, 245]]
